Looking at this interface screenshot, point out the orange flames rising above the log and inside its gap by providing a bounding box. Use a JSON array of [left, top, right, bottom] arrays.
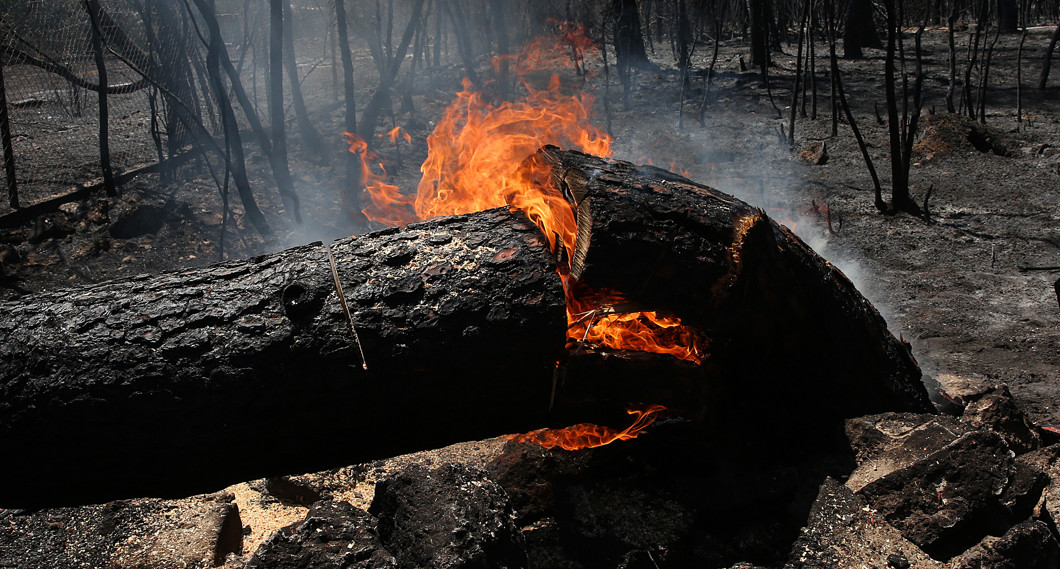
[[347, 24, 703, 372]]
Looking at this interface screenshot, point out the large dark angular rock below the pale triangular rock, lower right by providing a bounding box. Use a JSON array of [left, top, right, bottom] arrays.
[[858, 431, 1014, 559]]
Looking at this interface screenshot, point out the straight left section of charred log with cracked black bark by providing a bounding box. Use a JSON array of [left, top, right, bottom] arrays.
[[0, 210, 565, 506]]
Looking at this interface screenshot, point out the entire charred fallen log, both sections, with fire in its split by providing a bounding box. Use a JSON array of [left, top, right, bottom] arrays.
[[0, 147, 932, 505]]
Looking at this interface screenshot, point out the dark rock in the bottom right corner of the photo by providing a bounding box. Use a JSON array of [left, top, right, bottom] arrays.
[[952, 520, 1060, 569]]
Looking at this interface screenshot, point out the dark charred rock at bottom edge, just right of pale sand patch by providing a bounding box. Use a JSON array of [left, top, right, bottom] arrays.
[[246, 500, 398, 569]]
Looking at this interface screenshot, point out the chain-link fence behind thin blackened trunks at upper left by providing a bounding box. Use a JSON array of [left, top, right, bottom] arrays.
[[0, 0, 334, 212]]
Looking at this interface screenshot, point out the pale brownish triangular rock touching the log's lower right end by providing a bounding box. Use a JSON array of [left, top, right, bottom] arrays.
[[846, 413, 974, 491]]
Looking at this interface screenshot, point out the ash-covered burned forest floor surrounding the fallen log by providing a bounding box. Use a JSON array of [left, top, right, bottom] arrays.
[[0, 19, 1060, 567]]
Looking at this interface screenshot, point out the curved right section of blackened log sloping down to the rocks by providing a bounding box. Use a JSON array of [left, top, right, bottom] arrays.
[[534, 147, 933, 437]]
